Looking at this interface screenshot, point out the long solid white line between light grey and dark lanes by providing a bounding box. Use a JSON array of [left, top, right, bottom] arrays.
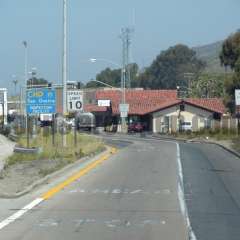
[[176, 143, 197, 240]]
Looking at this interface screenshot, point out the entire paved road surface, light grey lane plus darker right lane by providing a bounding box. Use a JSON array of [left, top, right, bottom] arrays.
[[0, 136, 240, 240]]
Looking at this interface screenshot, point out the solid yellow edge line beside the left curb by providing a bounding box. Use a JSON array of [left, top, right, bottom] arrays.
[[42, 148, 117, 200]]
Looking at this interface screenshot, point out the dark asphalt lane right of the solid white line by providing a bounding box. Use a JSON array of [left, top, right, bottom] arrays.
[[180, 144, 240, 240]]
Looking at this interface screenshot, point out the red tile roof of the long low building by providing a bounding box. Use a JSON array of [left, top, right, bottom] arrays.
[[93, 90, 226, 115]]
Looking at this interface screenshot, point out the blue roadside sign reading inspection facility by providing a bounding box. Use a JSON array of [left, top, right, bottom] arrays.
[[26, 88, 56, 114]]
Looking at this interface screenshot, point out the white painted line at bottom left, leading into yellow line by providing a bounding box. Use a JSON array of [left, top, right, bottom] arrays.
[[0, 198, 44, 230]]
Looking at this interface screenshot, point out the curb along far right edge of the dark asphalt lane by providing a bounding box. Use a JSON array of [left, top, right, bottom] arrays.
[[152, 136, 240, 158]]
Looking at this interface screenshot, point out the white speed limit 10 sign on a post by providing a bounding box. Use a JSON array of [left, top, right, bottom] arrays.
[[67, 90, 83, 112]]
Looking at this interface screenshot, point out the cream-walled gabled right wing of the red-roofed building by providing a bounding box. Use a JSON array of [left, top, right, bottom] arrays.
[[152, 99, 225, 133]]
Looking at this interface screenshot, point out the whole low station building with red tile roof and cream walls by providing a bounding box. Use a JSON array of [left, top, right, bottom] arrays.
[[84, 89, 227, 133]]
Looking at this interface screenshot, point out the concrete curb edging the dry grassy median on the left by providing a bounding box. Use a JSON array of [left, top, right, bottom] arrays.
[[0, 146, 112, 199]]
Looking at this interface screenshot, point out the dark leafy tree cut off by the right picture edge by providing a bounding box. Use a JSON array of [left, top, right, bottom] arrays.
[[219, 31, 240, 113]]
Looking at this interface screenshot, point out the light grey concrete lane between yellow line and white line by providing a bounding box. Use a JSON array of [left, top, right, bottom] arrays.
[[0, 139, 187, 240]]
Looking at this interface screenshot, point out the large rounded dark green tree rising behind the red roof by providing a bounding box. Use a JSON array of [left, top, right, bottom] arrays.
[[138, 44, 205, 89]]
